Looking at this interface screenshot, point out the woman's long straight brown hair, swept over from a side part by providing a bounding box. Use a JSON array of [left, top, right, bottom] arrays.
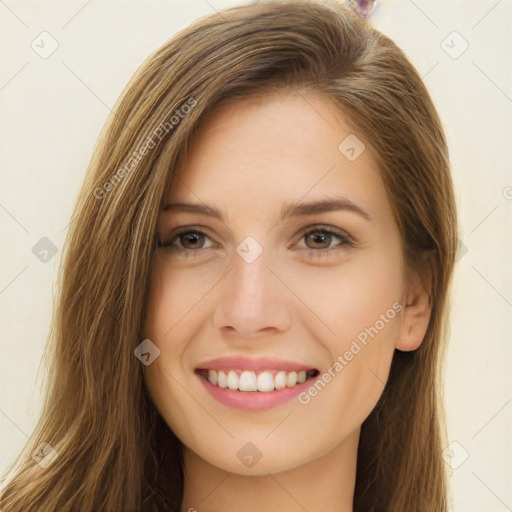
[[2, 1, 457, 512]]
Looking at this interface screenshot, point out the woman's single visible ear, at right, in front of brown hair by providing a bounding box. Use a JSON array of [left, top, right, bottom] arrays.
[[395, 268, 432, 352]]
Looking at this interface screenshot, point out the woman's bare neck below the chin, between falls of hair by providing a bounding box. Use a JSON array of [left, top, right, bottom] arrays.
[[181, 429, 360, 512]]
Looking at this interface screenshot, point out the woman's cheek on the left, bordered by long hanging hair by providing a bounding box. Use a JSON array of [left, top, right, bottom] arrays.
[[144, 255, 226, 432]]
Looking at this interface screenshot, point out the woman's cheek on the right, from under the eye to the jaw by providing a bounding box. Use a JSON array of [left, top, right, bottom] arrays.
[[282, 251, 402, 422]]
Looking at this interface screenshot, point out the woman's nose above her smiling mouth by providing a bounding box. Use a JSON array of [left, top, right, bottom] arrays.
[[213, 252, 292, 338]]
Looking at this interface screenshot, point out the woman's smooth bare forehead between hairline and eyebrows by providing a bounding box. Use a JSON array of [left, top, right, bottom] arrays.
[[167, 92, 388, 224]]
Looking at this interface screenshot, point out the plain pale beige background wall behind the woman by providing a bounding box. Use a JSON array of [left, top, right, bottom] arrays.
[[0, 0, 512, 512]]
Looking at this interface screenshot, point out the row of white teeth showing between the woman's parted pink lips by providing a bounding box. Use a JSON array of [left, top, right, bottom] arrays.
[[196, 369, 319, 393]]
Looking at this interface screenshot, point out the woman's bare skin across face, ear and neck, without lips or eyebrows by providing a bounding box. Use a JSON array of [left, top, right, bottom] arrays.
[[145, 93, 430, 512]]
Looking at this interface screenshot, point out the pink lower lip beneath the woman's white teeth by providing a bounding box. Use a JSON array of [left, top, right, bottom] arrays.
[[198, 375, 317, 410]]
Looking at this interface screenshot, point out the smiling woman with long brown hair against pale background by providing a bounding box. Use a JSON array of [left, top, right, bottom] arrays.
[[2, 1, 457, 512]]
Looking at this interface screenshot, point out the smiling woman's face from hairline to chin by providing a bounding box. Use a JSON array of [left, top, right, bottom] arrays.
[[145, 93, 421, 475]]
